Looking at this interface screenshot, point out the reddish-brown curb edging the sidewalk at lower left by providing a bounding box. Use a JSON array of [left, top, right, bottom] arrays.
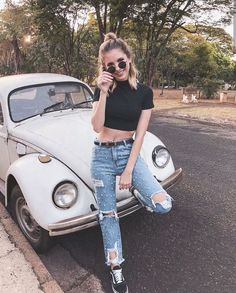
[[0, 203, 64, 293]]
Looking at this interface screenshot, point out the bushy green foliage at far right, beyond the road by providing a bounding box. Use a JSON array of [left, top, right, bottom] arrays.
[[158, 25, 234, 95]]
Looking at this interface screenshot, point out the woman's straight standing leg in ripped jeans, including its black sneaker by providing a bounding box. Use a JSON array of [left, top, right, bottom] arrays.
[[91, 147, 128, 293]]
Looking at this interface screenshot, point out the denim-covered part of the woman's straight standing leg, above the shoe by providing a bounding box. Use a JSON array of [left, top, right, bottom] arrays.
[[91, 147, 124, 267]]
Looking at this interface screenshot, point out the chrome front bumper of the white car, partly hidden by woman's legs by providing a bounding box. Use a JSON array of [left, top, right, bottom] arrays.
[[48, 168, 182, 236]]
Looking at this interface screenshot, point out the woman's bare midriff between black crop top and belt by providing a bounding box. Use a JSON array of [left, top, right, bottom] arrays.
[[98, 127, 134, 142]]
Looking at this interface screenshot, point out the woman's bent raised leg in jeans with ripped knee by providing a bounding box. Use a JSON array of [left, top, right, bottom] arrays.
[[132, 155, 172, 214]]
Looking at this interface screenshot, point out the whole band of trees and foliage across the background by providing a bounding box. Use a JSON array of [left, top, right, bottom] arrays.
[[0, 0, 236, 93]]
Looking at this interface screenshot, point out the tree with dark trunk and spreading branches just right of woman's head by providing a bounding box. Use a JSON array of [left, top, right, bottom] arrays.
[[85, 0, 232, 84]]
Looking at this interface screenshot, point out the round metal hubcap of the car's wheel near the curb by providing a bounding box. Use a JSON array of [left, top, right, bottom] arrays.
[[16, 197, 41, 242]]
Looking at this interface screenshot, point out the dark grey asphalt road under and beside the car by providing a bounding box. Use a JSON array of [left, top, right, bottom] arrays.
[[38, 115, 236, 293]]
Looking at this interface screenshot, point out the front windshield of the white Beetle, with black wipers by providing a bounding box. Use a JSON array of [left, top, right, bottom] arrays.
[[9, 82, 92, 122]]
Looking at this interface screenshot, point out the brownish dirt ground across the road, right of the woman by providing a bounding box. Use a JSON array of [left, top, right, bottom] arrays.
[[154, 90, 236, 124]]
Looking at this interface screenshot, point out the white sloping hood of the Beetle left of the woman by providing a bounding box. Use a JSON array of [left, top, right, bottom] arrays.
[[10, 110, 96, 186]]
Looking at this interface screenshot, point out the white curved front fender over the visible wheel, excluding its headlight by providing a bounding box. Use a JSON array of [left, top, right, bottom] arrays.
[[6, 153, 96, 230]]
